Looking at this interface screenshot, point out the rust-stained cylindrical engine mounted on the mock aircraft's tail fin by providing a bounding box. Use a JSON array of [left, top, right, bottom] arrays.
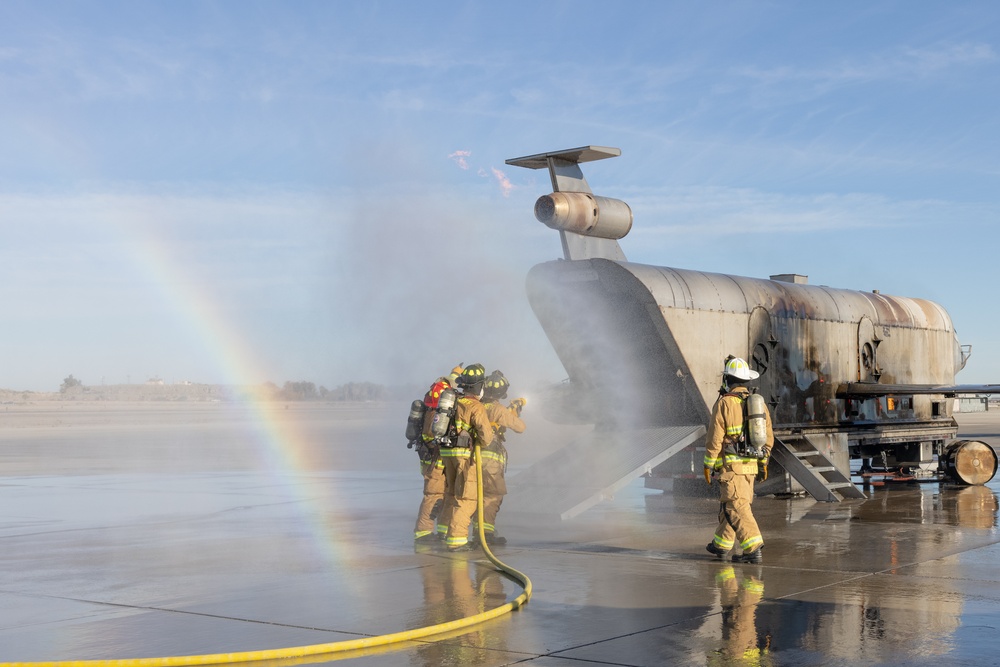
[[535, 192, 632, 240]]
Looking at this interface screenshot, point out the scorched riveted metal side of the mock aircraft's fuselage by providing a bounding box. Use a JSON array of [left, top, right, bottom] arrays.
[[624, 264, 956, 426]]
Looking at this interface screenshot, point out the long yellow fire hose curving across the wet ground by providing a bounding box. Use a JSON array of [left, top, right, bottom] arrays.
[[0, 445, 531, 667]]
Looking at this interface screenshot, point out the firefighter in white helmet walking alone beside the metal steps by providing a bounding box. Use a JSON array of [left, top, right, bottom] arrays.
[[704, 357, 774, 563]]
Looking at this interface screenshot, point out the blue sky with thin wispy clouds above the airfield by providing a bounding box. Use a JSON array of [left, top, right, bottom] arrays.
[[0, 0, 1000, 391]]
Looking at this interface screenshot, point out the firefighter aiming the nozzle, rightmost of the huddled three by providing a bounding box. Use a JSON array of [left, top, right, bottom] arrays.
[[473, 371, 528, 545]]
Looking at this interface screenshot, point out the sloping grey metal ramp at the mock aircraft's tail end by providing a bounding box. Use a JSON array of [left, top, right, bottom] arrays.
[[503, 424, 705, 520]]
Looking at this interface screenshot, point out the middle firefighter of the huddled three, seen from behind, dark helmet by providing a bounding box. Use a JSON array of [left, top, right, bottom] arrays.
[[441, 364, 493, 551]]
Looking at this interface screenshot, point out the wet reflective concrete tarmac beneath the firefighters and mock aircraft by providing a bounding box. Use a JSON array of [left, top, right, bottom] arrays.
[[0, 404, 1000, 667]]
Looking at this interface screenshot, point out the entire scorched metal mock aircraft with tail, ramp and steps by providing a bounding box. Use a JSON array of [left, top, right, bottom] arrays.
[[505, 146, 1000, 518]]
